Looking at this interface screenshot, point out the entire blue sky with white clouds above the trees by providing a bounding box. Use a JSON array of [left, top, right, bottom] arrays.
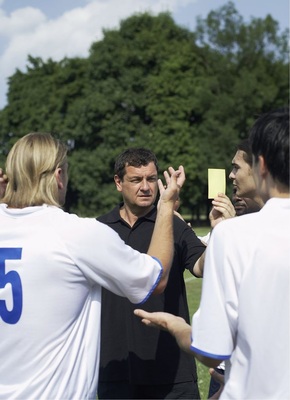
[[0, 0, 289, 109]]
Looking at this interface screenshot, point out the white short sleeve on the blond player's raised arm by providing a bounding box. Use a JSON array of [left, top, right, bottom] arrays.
[[59, 218, 162, 303]]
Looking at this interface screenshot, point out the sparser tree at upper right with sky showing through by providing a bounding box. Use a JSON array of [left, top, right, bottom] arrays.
[[196, 2, 289, 137]]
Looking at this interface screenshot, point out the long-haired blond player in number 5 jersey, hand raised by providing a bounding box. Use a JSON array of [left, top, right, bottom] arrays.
[[0, 133, 184, 400]]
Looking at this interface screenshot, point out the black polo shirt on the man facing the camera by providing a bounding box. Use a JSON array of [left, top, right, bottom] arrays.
[[98, 204, 205, 385]]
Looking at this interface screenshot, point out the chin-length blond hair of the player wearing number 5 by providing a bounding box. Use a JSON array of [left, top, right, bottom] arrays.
[[1, 132, 67, 208]]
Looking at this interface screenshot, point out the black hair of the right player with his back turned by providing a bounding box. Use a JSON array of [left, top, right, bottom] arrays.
[[249, 107, 289, 187]]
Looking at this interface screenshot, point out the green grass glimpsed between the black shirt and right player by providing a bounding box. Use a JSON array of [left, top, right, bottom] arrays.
[[184, 227, 210, 400]]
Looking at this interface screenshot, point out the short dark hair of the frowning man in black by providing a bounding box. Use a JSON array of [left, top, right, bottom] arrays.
[[114, 148, 158, 180]]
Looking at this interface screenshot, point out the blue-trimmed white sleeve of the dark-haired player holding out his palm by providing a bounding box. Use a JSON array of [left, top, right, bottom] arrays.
[[191, 224, 239, 360]]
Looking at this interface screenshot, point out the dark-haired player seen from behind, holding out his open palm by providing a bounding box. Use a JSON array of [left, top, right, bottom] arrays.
[[135, 108, 290, 400]]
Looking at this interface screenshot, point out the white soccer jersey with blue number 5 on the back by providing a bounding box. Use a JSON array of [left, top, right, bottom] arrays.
[[0, 204, 162, 400]]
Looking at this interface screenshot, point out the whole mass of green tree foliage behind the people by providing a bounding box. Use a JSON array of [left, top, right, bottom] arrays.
[[0, 2, 289, 216]]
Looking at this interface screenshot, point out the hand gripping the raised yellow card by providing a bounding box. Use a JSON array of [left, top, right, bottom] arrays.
[[209, 193, 236, 229]]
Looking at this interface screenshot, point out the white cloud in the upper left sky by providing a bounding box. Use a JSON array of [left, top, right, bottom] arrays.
[[0, 0, 195, 109]]
